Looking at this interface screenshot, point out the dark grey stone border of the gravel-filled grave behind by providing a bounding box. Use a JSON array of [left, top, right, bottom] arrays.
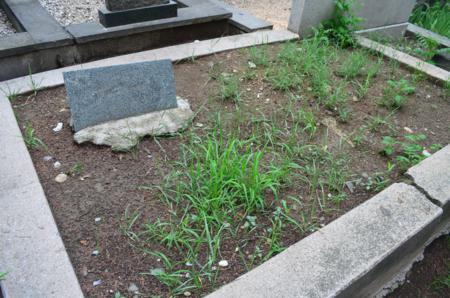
[[0, 0, 273, 81]]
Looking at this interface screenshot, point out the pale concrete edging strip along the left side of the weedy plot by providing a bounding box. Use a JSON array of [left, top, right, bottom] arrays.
[[0, 95, 83, 298]]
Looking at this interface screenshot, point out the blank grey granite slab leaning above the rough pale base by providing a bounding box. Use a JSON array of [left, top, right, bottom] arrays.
[[64, 60, 177, 132]]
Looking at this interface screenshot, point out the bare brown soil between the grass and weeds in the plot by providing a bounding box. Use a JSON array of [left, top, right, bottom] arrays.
[[13, 45, 450, 297]]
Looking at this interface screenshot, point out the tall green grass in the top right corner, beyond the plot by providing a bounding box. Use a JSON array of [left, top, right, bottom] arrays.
[[410, 1, 450, 38]]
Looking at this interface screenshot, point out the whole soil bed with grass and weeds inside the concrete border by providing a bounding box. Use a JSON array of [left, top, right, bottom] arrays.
[[10, 38, 450, 297]]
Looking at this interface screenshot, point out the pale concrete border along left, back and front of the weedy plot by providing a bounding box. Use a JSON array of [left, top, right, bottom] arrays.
[[0, 30, 450, 298]]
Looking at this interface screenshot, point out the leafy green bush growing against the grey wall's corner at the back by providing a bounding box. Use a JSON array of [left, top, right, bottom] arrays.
[[319, 0, 362, 47]]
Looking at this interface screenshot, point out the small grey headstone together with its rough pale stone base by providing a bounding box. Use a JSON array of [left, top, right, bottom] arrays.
[[64, 60, 193, 150]]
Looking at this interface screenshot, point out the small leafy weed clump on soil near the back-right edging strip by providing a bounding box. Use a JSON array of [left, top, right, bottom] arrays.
[[379, 79, 416, 109]]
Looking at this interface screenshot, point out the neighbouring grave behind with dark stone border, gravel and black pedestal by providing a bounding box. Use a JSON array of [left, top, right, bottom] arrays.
[[0, 0, 272, 81]]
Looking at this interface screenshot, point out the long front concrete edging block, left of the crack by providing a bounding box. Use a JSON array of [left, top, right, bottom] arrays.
[[207, 183, 442, 298]]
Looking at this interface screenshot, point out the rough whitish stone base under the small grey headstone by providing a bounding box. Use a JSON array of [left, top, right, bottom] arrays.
[[74, 98, 194, 151]]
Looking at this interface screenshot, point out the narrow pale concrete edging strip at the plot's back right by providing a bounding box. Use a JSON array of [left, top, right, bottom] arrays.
[[356, 36, 450, 82]]
